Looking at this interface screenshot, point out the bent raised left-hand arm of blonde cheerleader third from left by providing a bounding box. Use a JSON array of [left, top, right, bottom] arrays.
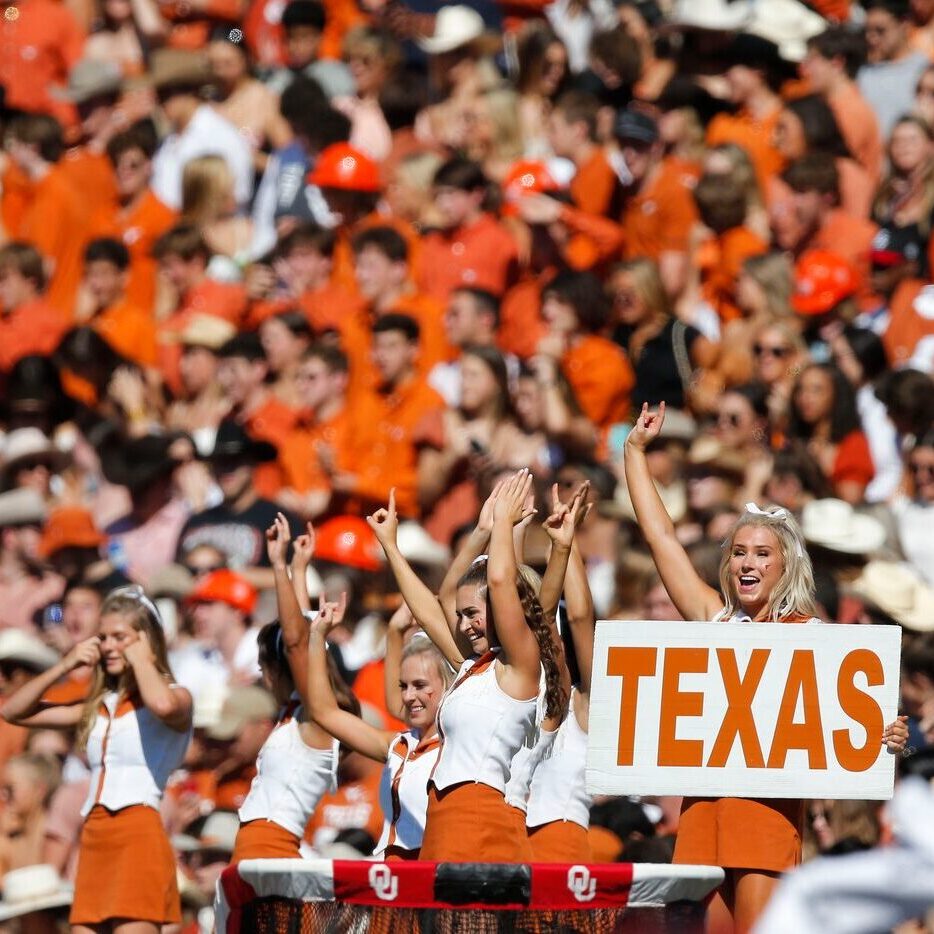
[[305, 603, 393, 762]]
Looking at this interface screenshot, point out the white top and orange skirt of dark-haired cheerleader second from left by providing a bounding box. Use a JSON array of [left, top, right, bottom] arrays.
[[230, 698, 338, 863]]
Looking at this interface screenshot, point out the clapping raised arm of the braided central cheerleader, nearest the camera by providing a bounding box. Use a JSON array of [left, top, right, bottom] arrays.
[[487, 468, 541, 698]]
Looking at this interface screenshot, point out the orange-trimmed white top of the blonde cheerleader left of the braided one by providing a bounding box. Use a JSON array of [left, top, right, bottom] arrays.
[[374, 730, 441, 856]]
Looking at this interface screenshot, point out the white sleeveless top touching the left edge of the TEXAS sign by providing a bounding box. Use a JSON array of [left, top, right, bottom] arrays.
[[525, 691, 592, 828]]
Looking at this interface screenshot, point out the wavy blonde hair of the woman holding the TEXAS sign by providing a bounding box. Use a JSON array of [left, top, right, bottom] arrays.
[[720, 506, 817, 623]]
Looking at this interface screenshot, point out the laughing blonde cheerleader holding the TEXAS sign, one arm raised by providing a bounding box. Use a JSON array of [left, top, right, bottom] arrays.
[[625, 402, 908, 931]]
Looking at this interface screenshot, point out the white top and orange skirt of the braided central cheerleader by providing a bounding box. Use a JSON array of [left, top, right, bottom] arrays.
[[421, 652, 538, 862]]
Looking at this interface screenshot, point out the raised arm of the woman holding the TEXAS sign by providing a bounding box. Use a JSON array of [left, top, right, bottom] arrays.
[[625, 402, 723, 620]]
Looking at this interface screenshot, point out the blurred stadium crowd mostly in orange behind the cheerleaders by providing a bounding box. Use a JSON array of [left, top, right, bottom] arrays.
[[0, 0, 934, 932]]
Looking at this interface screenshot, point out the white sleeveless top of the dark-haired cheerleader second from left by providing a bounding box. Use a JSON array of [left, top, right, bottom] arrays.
[[237, 700, 338, 837]]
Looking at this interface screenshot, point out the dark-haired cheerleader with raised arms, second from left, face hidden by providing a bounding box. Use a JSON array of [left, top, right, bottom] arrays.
[[230, 513, 360, 863]]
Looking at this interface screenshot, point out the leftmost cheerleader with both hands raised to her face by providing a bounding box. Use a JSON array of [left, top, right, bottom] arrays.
[[3, 587, 192, 934]]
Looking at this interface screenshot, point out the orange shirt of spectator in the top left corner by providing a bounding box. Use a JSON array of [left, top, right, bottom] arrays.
[[0, 0, 84, 124]]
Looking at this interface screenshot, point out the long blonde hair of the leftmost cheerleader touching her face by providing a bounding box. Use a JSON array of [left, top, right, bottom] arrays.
[[75, 587, 173, 750]]
